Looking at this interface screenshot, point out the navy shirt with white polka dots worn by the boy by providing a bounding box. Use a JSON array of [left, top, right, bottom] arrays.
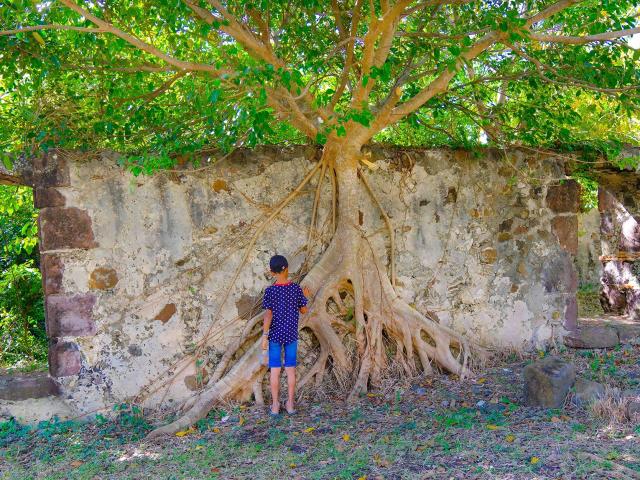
[[262, 282, 307, 345]]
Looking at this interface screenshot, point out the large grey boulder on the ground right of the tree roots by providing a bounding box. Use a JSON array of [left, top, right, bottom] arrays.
[[523, 357, 576, 408]]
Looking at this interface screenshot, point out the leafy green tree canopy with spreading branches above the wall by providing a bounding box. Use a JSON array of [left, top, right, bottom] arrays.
[[0, 0, 640, 173]]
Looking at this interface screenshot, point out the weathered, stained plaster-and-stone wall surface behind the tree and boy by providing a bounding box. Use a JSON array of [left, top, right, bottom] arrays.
[[0, 147, 578, 420]]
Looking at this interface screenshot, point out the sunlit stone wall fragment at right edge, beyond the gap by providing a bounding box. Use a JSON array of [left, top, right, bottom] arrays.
[[598, 171, 640, 320]]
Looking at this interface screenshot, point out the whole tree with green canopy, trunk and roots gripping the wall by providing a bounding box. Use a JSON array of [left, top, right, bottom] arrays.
[[0, 0, 640, 434]]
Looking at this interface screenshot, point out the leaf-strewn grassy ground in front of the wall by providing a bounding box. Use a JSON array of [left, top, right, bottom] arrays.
[[0, 340, 640, 480]]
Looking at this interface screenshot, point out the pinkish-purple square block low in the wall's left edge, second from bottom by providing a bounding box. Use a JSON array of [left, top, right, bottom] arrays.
[[45, 293, 96, 337]]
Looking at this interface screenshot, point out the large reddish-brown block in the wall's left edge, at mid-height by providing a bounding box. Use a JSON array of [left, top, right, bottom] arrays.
[[39, 207, 98, 251]]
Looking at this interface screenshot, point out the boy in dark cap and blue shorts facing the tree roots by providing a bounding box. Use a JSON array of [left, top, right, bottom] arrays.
[[262, 255, 309, 415]]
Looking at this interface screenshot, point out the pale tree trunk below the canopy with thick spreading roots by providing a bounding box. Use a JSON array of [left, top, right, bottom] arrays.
[[149, 148, 470, 438]]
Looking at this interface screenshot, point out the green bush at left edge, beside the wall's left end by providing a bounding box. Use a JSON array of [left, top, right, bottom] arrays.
[[0, 260, 47, 370]]
